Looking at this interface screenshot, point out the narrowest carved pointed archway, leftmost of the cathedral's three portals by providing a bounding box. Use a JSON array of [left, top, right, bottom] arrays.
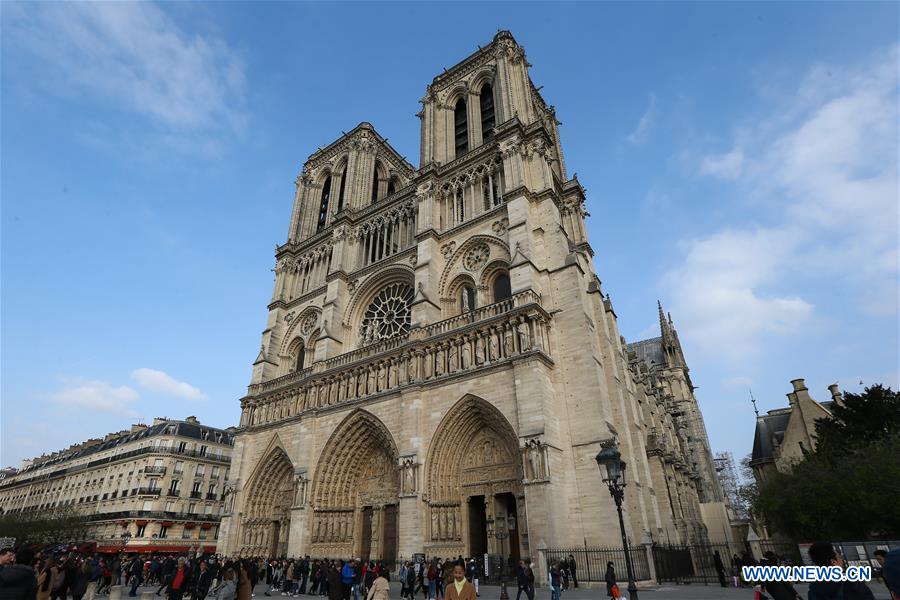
[[240, 438, 295, 556]]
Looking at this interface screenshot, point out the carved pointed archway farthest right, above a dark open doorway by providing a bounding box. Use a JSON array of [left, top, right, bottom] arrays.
[[425, 395, 525, 556]]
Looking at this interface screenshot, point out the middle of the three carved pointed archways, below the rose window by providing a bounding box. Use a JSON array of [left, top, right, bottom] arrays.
[[310, 409, 400, 562]]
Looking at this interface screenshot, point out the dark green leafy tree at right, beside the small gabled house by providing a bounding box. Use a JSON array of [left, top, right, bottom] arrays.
[[754, 385, 900, 541]]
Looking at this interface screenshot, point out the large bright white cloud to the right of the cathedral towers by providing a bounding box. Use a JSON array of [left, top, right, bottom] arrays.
[[664, 47, 900, 362]]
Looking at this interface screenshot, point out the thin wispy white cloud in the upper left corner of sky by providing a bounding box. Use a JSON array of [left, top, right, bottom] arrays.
[[5, 2, 245, 142]]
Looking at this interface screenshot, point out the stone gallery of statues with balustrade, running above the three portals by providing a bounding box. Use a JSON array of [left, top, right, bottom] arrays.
[[240, 291, 550, 428]]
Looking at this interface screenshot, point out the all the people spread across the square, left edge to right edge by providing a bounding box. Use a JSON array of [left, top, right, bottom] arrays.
[[0, 542, 900, 600]]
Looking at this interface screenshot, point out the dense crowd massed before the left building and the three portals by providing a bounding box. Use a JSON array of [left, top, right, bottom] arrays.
[[0, 547, 536, 600]]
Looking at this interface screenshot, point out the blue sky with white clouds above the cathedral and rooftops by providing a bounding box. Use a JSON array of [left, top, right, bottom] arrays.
[[0, 2, 900, 474]]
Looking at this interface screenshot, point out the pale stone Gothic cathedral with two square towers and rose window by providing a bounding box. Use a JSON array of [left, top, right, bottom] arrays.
[[218, 31, 728, 561]]
